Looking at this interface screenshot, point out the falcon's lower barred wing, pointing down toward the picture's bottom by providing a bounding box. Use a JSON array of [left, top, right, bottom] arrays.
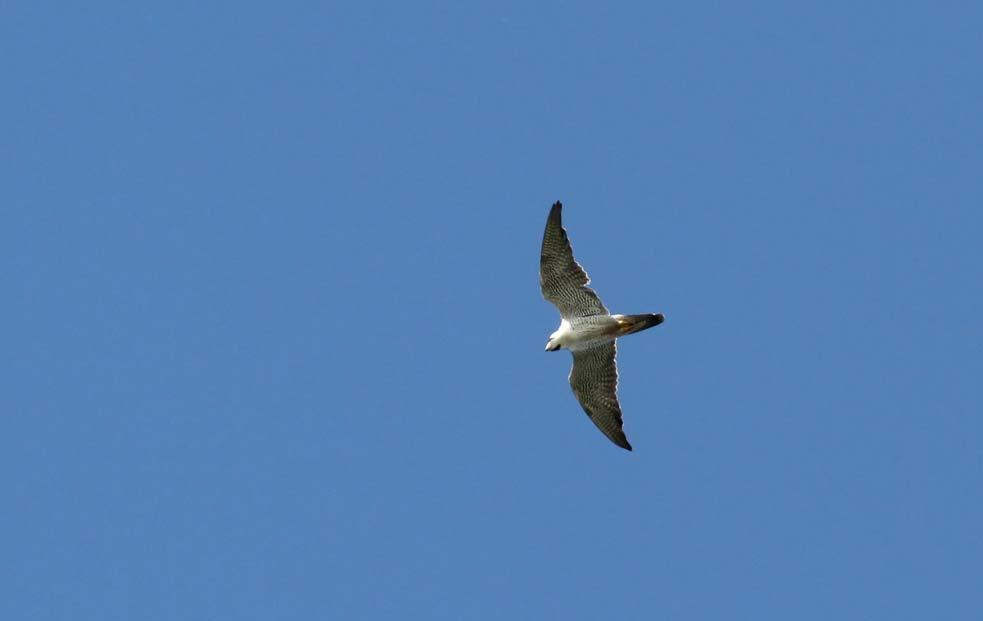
[[570, 341, 631, 451]]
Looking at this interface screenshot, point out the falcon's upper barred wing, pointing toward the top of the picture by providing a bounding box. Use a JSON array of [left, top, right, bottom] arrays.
[[539, 201, 608, 319]]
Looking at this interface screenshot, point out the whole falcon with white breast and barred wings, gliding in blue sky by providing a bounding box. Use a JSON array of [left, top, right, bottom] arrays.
[[539, 201, 665, 451]]
